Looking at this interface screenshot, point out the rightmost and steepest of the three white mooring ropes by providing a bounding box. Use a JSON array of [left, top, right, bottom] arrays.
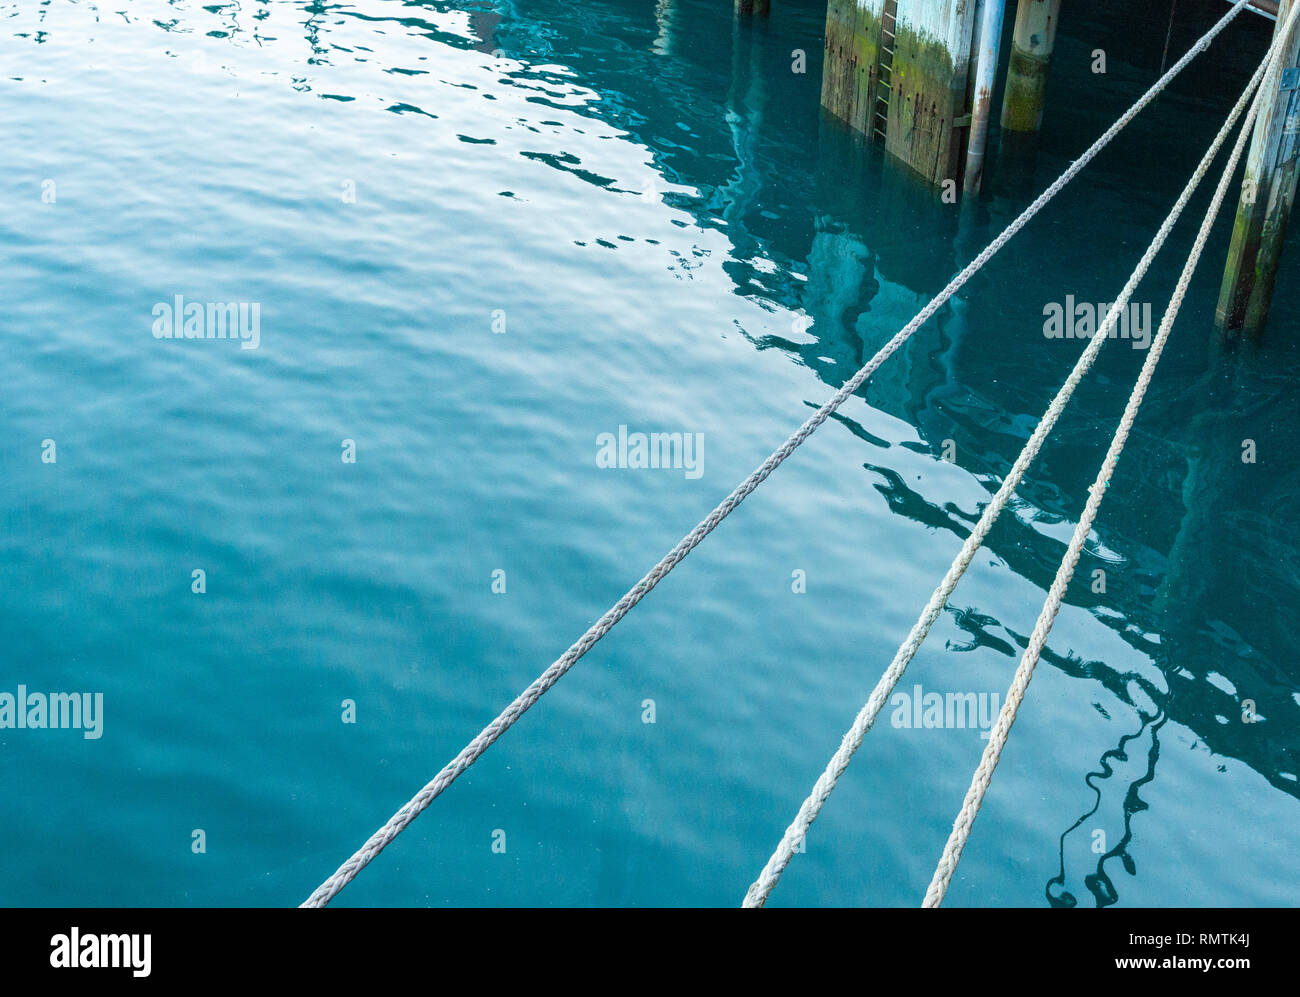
[[922, 4, 1300, 907]]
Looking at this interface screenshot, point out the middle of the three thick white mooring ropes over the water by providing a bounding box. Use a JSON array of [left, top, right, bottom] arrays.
[[742, 15, 1265, 907]]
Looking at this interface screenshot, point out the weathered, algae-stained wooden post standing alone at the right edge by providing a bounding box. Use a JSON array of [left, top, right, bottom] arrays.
[[1214, 0, 1300, 335]]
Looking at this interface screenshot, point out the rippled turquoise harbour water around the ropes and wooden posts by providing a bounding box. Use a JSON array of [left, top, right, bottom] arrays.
[[0, 0, 1300, 906]]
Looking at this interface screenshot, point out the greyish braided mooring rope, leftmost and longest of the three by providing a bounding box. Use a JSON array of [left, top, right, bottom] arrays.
[[300, 0, 1249, 907]]
